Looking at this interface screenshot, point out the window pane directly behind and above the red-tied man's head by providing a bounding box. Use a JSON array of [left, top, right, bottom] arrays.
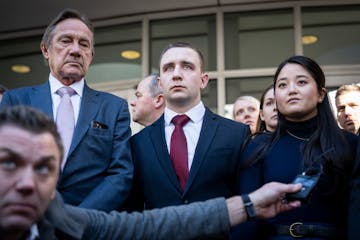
[[150, 15, 216, 72]]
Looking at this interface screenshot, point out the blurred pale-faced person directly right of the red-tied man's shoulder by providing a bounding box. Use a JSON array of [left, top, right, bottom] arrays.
[[233, 96, 260, 134]]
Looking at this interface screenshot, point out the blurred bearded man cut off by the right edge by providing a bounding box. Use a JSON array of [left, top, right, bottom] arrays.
[[335, 84, 360, 135]]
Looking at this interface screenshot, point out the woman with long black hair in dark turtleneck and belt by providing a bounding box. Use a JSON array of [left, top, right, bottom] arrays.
[[239, 56, 357, 239]]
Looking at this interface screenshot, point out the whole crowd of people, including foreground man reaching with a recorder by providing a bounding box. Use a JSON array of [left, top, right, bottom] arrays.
[[0, 6, 360, 240]]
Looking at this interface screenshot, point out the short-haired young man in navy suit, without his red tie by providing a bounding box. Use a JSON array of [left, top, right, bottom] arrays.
[[131, 43, 250, 210]]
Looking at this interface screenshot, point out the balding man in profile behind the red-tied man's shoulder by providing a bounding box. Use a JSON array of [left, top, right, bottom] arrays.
[[130, 74, 165, 127]]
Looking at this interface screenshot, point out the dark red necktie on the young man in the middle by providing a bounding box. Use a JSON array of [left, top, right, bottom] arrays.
[[170, 115, 190, 189]]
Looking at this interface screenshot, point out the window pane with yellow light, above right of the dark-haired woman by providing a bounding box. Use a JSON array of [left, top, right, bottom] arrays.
[[301, 5, 360, 65]]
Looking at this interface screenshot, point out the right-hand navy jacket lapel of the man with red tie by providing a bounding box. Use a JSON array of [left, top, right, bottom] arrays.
[[184, 108, 219, 193]]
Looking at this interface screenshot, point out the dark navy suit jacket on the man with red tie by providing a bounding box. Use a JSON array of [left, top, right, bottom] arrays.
[[130, 109, 250, 210]]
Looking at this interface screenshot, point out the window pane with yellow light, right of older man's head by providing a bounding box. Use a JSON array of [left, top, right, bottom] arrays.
[[86, 23, 142, 83]]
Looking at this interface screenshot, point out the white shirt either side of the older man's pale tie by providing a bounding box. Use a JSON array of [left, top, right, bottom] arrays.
[[49, 74, 85, 125]]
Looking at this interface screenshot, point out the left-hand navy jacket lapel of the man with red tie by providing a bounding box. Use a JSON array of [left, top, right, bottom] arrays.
[[149, 115, 182, 192]]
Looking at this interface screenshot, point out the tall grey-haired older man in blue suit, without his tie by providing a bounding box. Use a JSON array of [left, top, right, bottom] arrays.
[[0, 9, 133, 211]]
